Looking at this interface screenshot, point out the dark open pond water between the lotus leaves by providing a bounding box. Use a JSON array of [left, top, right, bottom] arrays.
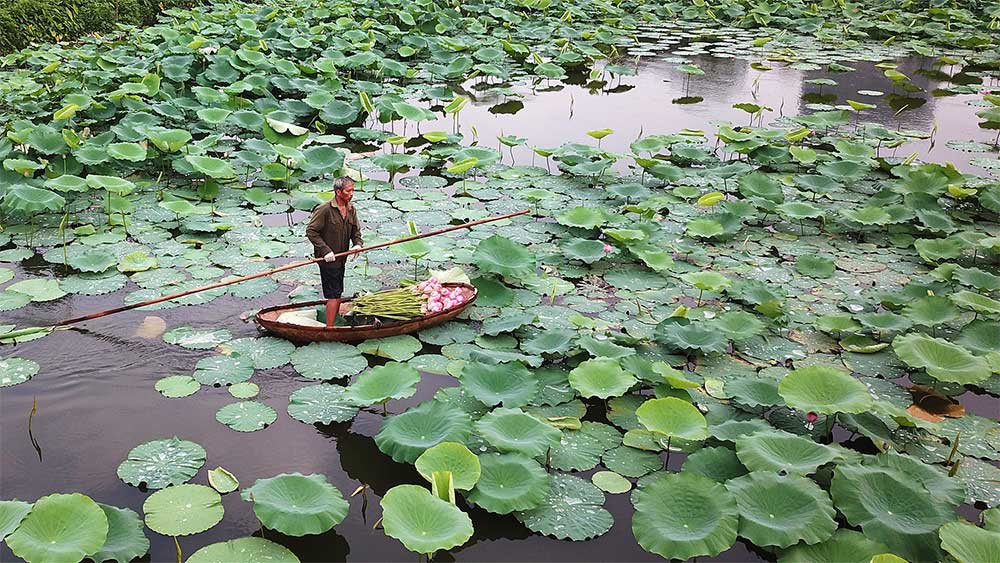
[[0, 49, 1000, 561]]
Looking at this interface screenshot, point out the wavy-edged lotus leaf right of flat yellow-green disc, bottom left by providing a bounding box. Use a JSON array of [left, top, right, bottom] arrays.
[[240, 473, 348, 536]]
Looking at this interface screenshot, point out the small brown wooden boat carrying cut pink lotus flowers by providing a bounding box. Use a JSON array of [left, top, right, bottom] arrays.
[[254, 283, 477, 343]]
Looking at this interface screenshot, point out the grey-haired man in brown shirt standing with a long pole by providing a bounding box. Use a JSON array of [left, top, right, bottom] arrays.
[[306, 176, 361, 327]]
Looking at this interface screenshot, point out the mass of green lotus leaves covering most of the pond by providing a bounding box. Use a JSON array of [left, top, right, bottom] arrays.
[[0, 0, 1000, 561]]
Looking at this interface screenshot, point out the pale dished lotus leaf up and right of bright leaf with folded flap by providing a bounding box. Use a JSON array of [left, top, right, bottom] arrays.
[[476, 407, 562, 457]]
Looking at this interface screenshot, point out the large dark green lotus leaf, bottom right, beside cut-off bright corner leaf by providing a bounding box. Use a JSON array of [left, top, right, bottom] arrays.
[[830, 465, 955, 561]]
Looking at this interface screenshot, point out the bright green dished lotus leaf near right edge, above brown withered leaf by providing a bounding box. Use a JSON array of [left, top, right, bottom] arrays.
[[892, 333, 992, 385]]
